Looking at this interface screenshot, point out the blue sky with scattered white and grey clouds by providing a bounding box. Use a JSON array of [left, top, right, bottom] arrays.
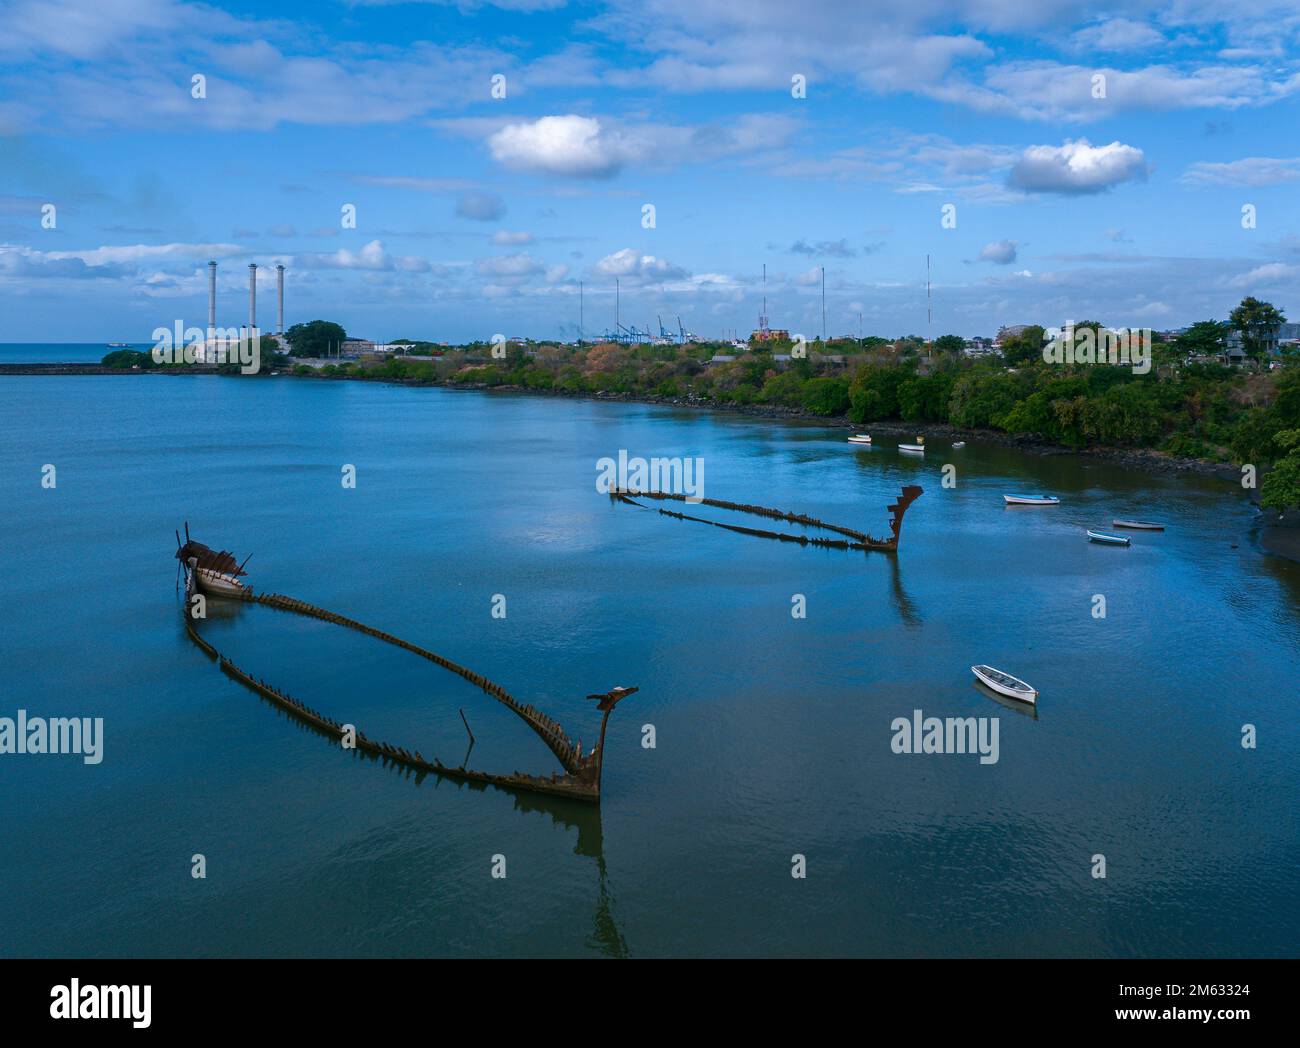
[[0, 0, 1300, 342]]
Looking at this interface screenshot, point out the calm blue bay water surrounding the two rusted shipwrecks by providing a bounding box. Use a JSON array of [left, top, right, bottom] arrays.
[[0, 376, 1300, 956]]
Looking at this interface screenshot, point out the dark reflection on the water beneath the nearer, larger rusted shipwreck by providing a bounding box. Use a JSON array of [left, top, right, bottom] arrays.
[[181, 599, 631, 957]]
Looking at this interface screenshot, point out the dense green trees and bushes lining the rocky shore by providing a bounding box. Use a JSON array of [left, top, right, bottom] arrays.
[[105, 299, 1300, 508]]
